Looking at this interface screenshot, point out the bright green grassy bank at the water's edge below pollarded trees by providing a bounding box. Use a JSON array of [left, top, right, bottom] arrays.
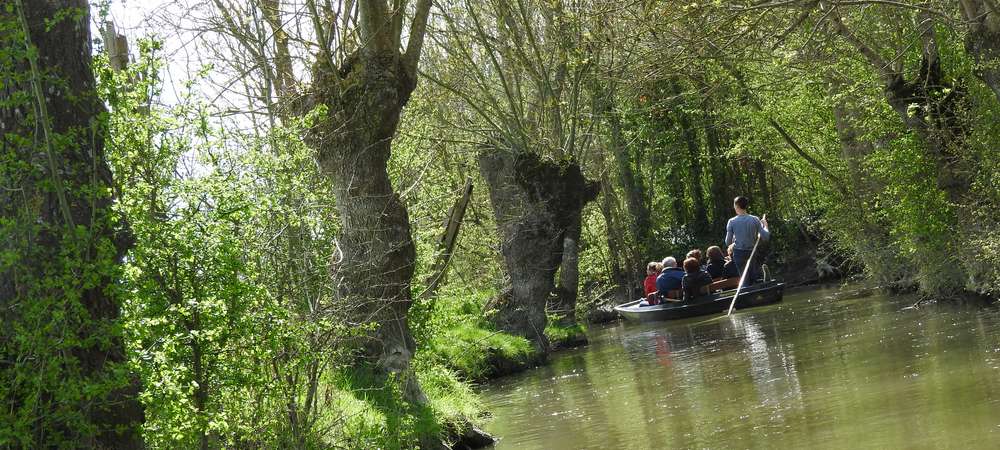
[[330, 291, 586, 448]]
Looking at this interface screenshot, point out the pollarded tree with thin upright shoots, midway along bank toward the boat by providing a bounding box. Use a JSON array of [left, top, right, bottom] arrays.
[[424, 0, 602, 352]]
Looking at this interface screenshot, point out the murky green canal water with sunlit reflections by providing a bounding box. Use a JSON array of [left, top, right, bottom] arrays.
[[483, 289, 1000, 449]]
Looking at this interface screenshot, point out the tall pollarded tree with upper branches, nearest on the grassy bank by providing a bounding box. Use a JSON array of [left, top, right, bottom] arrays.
[[197, 0, 432, 404]]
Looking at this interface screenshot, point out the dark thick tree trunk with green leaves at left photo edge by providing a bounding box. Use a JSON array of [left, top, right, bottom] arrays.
[[0, 0, 143, 449]]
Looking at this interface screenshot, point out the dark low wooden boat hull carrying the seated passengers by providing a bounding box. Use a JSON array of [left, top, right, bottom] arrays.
[[615, 280, 785, 322]]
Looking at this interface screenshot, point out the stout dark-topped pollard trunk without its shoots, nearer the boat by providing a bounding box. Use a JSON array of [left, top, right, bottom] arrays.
[[479, 149, 598, 353]]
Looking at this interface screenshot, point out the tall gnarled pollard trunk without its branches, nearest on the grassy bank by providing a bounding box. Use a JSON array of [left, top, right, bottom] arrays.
[[306, 47, 426, 403]]
